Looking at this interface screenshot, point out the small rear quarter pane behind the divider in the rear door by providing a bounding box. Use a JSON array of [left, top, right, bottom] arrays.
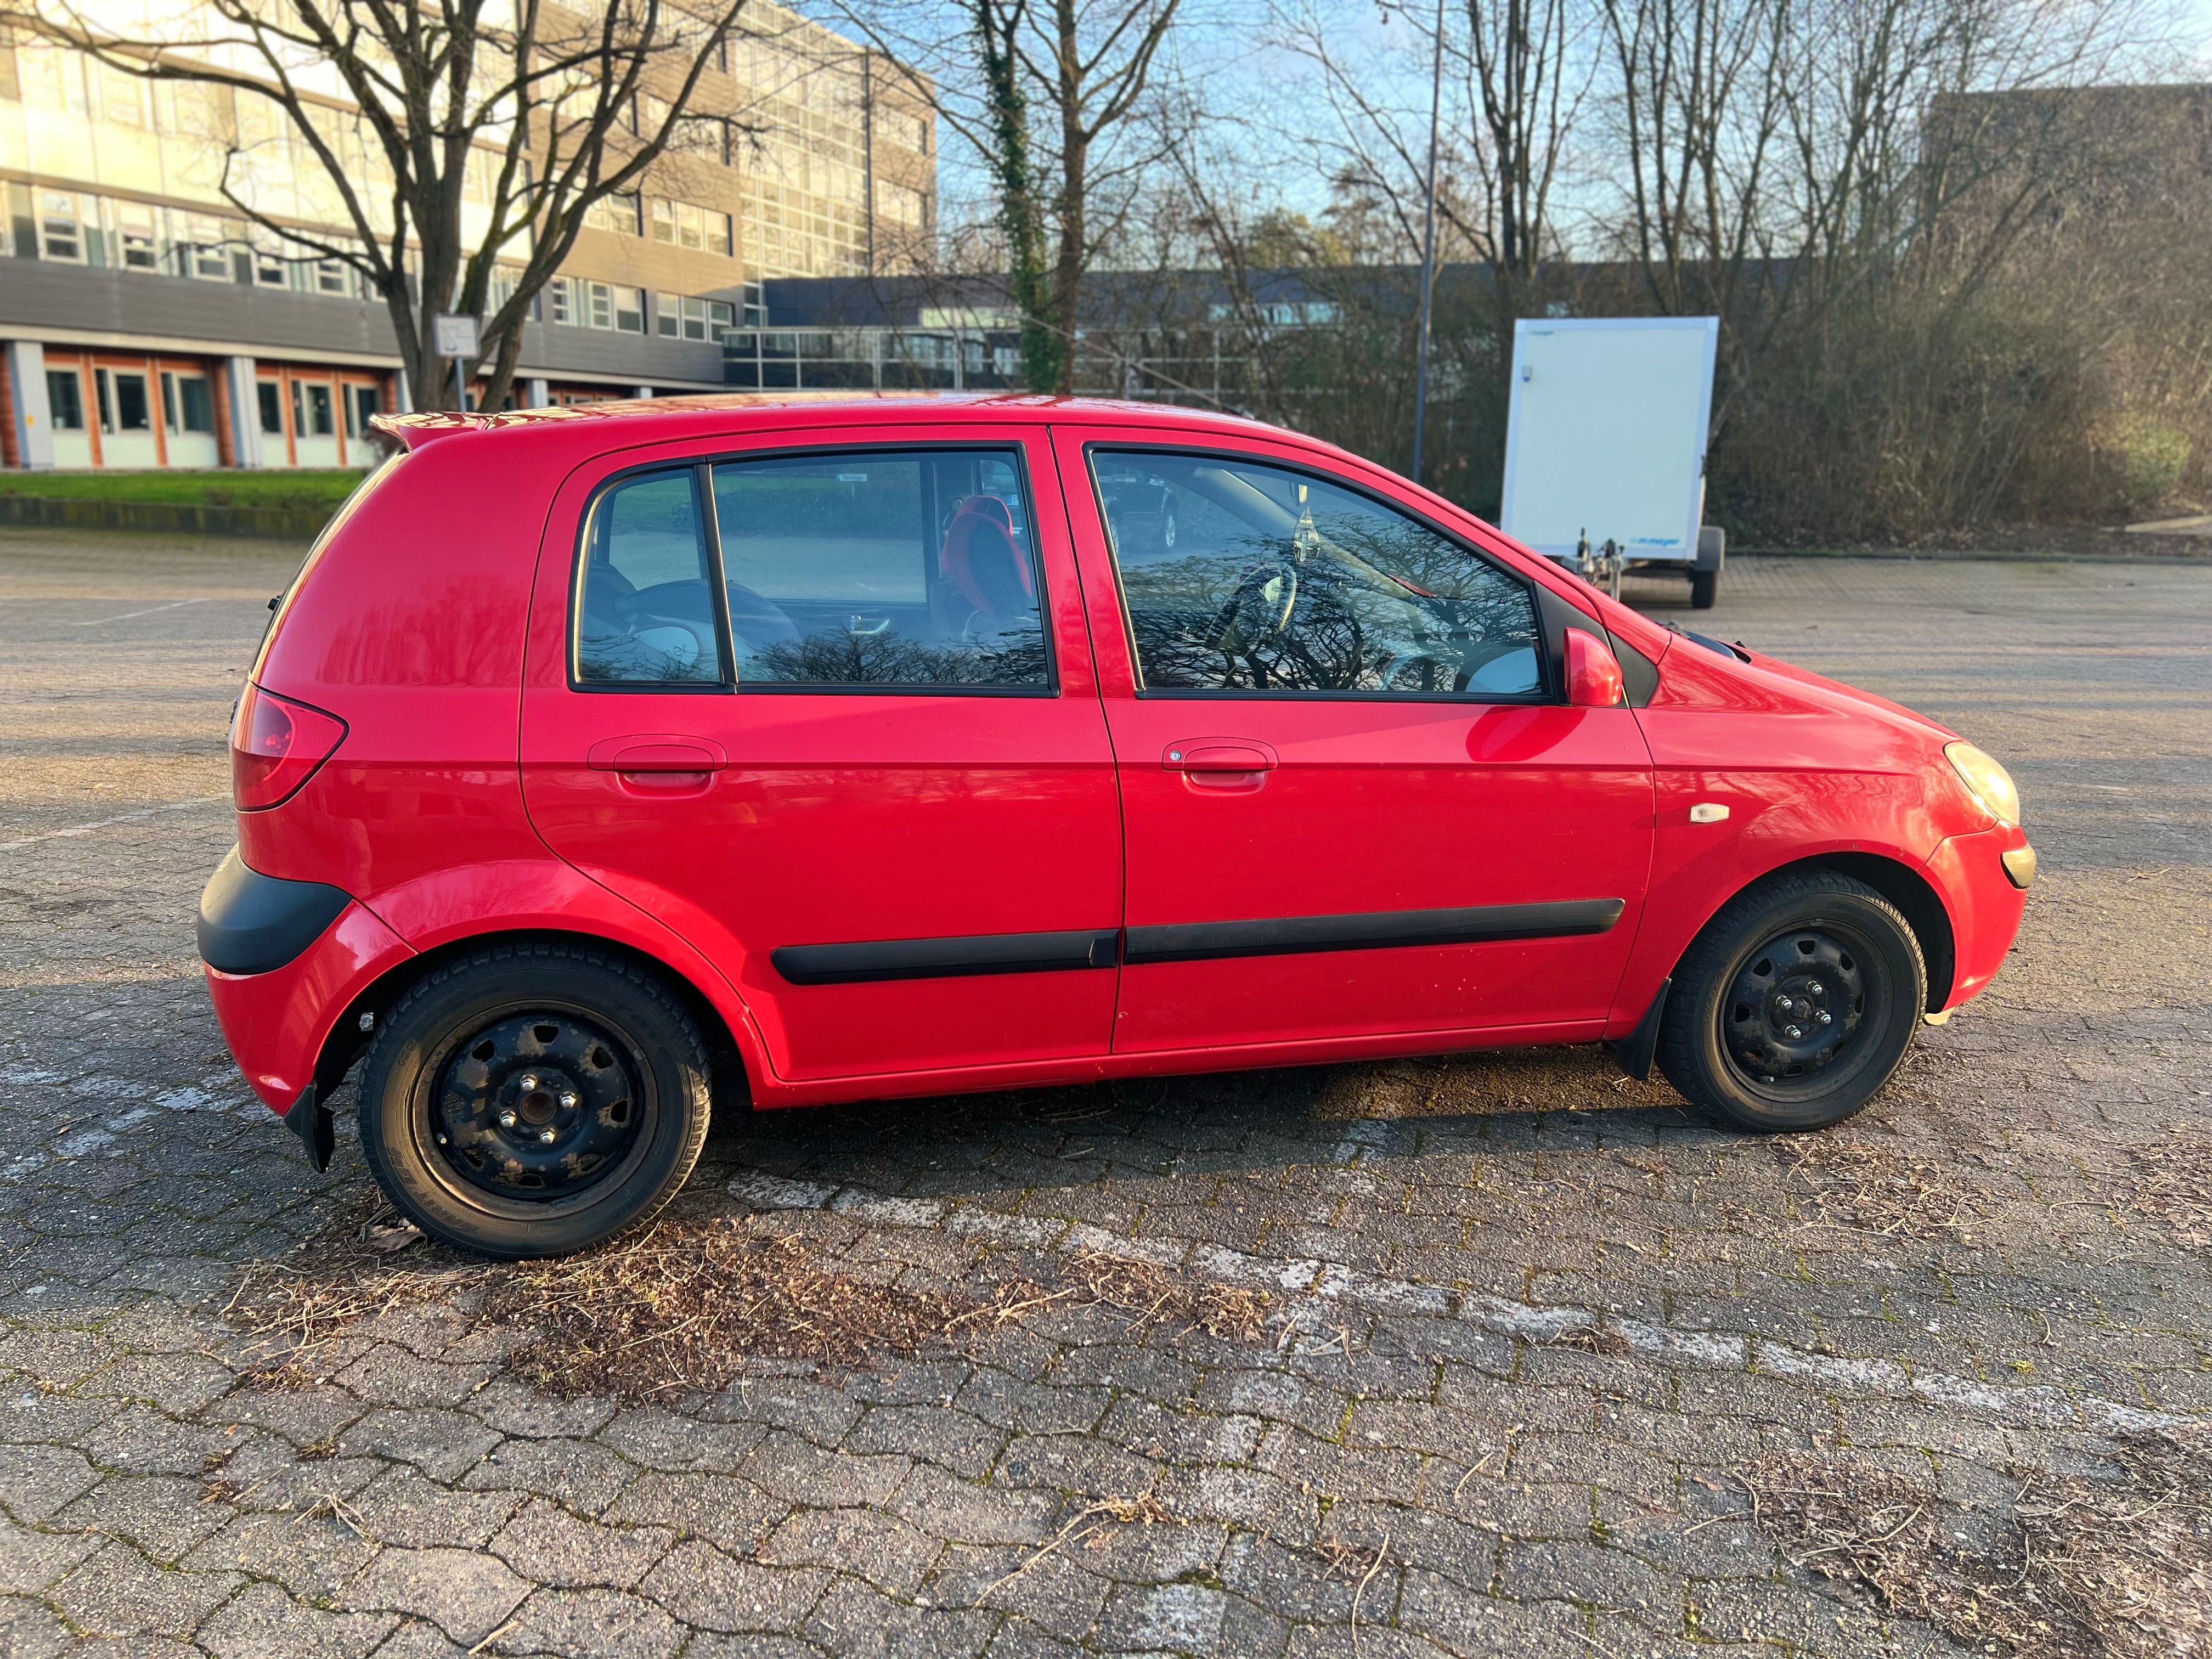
[[575, 467, 721, 686]]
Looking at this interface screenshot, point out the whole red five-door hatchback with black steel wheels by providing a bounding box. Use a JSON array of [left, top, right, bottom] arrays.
[[199, 398, 2035, 1256]]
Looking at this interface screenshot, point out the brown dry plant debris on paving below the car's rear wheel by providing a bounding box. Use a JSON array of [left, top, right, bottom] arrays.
[[228, 1212, 1267, 1400]]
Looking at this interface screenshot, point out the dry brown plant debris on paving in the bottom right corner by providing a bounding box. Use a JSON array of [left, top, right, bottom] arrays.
[[1745, 1431, 2212, 1659]]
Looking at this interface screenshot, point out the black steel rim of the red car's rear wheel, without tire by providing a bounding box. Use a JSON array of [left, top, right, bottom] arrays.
[[433, 1013, 639, 1199]]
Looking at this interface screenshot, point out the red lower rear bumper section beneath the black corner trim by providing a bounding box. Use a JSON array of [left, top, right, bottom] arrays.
[[206, 883, 414, 1113]]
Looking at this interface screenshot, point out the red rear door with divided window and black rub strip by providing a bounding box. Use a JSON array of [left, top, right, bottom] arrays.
[[522, 425, 1121, 1086]]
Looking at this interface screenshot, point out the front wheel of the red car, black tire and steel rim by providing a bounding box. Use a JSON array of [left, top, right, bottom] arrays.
[[1657, 870, 1927, 1132]]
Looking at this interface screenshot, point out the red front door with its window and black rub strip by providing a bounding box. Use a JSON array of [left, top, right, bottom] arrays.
[[1055, 427, 1652, 1051]]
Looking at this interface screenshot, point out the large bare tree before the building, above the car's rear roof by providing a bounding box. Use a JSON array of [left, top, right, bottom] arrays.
[[0, 0, 743, 409]]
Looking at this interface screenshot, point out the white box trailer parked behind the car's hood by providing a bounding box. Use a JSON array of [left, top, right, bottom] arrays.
[[1498, 317, 1725, 611]]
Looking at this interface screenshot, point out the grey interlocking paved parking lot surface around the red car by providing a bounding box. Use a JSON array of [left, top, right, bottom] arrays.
[[0, 531, 2212, 1659]]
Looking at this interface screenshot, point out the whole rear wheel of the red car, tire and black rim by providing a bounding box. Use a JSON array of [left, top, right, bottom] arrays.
[[358, 943, 710, 1261]]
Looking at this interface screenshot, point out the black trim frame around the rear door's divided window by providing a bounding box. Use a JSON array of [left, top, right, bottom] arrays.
[[564, 438, 1057, 699]]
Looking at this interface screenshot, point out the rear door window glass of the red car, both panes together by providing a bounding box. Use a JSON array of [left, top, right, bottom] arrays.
[[575, 449, 1053, 692]]
